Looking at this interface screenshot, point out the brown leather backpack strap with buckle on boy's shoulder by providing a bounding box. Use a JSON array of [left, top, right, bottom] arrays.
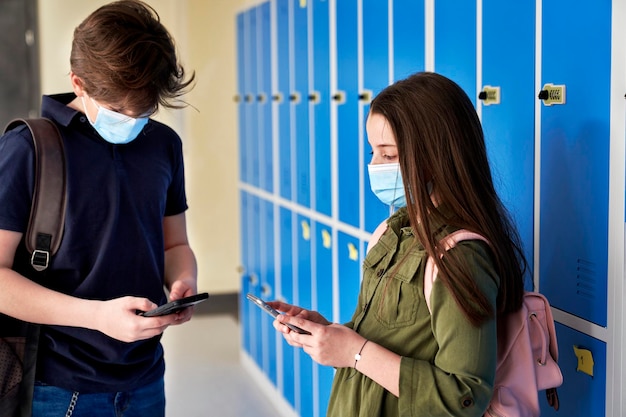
[[5, 118, 66, 271]]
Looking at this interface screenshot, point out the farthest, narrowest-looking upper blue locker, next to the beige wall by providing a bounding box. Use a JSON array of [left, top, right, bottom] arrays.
[[237, 12, 250, 182]]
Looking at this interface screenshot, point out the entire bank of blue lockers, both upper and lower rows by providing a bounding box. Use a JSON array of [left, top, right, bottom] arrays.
[[237, 0, 612, 417]]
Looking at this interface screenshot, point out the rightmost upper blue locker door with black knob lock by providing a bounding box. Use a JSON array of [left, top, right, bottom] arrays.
[[540, 0, 611, 326]]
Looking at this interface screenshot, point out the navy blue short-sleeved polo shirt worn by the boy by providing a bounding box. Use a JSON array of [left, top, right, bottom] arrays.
[[0, 94, 187, 392]]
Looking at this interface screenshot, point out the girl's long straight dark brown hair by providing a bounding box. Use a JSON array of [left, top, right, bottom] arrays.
[[370, 72, 527, 325]]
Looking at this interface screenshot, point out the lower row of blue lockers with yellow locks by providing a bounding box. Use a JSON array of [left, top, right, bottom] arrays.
[[240, 191, 606, 417]]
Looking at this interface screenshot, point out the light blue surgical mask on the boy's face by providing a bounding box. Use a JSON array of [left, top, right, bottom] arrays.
[[81, 96, 148, 145]]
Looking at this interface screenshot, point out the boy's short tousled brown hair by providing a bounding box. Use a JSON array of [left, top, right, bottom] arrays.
[[70, 0, 195, 114]]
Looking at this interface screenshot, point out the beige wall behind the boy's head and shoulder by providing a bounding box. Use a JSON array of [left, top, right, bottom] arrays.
[[39, 0, 255, 294]]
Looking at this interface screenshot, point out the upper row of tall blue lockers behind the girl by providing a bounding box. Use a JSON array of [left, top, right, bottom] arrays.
[[237, 0, 611, 326]]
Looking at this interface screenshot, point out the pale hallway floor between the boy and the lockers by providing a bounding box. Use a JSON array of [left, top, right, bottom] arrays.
[[163, 297, 279, 417]]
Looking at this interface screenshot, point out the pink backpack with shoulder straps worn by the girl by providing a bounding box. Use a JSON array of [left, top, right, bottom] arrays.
[[424, 229, 563, 417]]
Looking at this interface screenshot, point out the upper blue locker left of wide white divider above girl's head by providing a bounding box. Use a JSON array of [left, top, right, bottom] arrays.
[[392, 0, 426, 81]]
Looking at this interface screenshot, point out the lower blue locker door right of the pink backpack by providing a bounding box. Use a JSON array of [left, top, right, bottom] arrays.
[[539, 323, 606, 417]]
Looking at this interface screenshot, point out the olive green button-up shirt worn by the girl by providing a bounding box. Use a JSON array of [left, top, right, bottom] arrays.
[[327, 209, 499, 417]]
